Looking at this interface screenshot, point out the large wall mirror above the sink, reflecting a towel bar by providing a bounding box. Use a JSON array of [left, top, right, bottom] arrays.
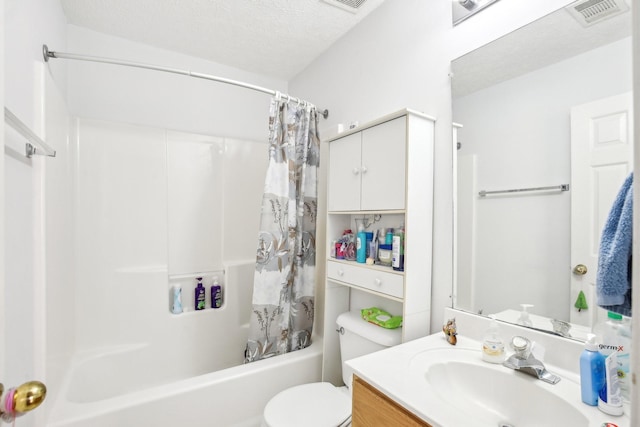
[[452, 0, 632, 339]]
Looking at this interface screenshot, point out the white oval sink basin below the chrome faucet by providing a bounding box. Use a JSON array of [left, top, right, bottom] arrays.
[[410, 349, 590, 427]]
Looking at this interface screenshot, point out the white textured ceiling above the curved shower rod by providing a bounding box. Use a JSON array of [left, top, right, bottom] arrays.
[[60, 0, 384, 80]]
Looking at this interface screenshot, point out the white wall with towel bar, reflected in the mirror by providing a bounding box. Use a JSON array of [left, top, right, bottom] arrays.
[[454, 38, 631, 321]]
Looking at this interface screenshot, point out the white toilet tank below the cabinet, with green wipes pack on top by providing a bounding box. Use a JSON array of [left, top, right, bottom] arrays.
[[336, 311, 402, 389]]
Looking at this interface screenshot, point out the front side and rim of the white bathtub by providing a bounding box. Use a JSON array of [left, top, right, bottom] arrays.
[[47, 338, 322, 427]]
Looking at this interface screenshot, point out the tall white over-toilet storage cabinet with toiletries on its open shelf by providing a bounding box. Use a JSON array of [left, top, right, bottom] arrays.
[[323, 109, 435, 385]]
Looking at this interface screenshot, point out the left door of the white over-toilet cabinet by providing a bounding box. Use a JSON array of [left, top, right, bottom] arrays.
[[327, 132, 362, 211]]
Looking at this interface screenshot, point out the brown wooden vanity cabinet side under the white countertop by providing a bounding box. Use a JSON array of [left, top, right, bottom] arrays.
[[351, 375, 432, 427]]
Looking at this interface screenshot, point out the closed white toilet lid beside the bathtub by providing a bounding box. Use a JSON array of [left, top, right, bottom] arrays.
[[263, 382, 351, 427]]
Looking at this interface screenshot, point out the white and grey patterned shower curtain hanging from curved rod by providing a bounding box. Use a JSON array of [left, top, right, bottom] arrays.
[[245, 94, 320, 363]]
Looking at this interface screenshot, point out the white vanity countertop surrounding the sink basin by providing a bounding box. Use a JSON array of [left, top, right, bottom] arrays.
[[346, 333, 629, 427]]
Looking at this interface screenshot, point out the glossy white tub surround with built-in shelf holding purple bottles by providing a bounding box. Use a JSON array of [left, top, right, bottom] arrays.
[[43, 118, 276, 426]]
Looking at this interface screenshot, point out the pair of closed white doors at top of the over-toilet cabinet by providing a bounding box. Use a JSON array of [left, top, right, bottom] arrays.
[[328, 117, 407, 211]]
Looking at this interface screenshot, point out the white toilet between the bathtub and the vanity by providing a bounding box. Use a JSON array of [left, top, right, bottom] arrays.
[[262, 312, 402, 427]]
